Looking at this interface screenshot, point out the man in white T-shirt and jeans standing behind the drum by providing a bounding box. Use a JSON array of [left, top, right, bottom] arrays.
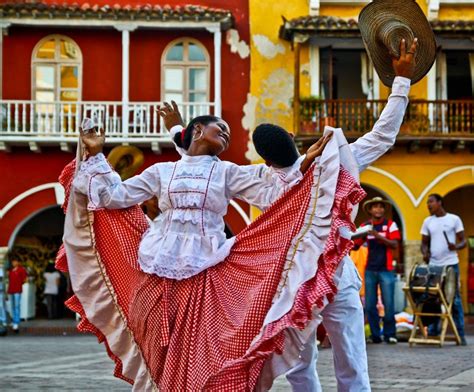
[[421, 193, 467, 346]]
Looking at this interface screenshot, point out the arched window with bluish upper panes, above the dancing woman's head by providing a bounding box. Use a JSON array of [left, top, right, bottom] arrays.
[[161, 38, 210, 118]]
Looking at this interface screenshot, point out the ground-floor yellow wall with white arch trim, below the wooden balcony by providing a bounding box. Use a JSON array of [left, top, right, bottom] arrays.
[[361, 149, 474, 308]]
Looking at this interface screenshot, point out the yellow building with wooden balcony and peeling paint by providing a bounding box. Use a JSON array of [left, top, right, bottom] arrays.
[[248, 0, 474, 306]]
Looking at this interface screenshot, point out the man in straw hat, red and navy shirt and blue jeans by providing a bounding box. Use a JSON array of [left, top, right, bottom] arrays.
[[355, 197, 400, 344]]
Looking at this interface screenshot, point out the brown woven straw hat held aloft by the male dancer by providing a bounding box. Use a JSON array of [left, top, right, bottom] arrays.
[[359, 0, 436, 87]]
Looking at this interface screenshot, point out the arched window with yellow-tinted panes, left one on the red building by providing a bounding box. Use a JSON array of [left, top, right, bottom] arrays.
[[31, 35, 82, 102]]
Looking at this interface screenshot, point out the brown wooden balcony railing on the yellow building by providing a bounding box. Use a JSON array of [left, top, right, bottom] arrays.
[[298, 98, 474, 138]]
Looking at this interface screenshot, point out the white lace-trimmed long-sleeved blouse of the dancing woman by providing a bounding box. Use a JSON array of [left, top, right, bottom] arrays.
[[73, 154, 302, 279]]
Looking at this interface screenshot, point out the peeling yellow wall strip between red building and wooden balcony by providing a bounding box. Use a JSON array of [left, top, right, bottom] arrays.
[[246, 0, 309, 160]]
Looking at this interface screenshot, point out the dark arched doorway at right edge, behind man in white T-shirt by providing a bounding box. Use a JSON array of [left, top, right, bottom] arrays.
[[444, 185, 474, 313]]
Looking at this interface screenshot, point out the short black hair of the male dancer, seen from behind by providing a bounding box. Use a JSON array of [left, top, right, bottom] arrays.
[[252, 124, 299, 167]]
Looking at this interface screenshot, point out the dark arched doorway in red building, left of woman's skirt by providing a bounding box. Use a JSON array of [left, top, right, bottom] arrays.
[[7, 205, 72, 318]]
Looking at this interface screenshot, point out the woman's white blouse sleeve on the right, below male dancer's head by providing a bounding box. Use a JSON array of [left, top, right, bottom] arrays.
[[226, 158, 303, 210]]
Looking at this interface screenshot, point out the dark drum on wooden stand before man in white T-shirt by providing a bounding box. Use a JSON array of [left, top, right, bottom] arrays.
[[409, 264, 456, 325]]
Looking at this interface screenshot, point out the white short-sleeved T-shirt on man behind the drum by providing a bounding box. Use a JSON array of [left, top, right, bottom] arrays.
[[421, 214, 464, 266]]
